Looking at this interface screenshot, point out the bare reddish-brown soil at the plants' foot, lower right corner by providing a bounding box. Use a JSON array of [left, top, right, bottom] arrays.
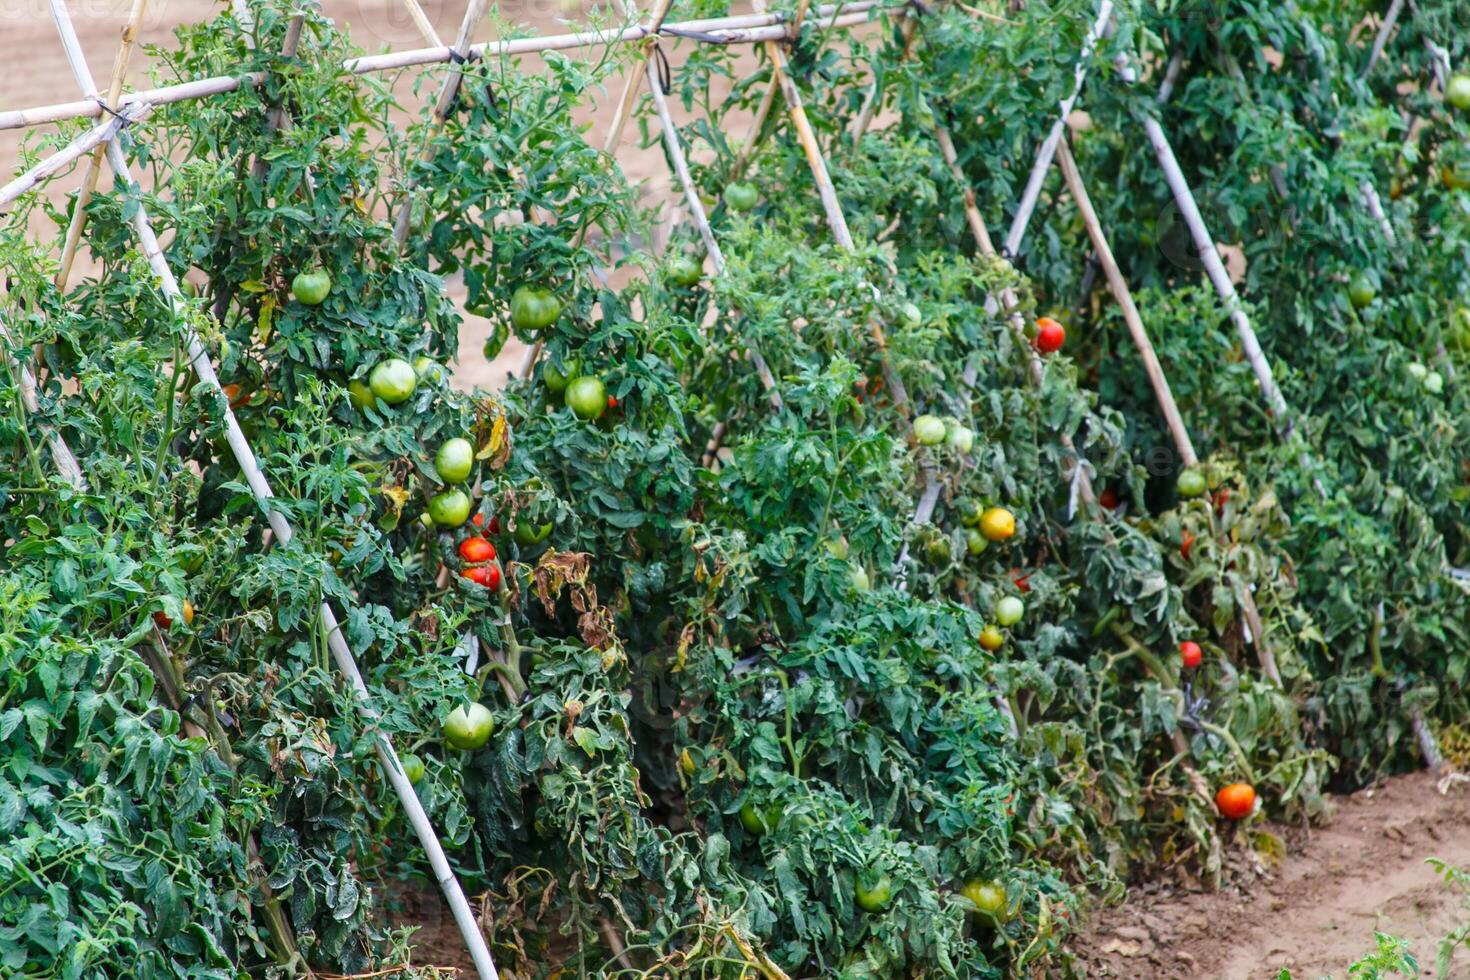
[[1079, 773, 1470, 980]]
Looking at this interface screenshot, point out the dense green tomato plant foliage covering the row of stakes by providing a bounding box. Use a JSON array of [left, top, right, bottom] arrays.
[[0, 0, 1470, 977]]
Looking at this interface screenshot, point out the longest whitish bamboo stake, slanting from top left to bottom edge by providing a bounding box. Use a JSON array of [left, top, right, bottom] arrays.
[[50, 0, 498, 980]]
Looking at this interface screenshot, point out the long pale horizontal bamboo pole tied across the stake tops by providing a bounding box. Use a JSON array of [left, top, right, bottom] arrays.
[[0, 0, 881, 129]]
